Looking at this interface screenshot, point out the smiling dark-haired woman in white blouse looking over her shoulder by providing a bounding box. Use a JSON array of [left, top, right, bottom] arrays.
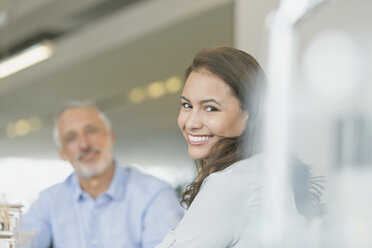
[[157, 47, 319, 248]]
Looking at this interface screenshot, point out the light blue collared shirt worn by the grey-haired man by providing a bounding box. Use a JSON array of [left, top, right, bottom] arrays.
[[22, 165, 183, 248]]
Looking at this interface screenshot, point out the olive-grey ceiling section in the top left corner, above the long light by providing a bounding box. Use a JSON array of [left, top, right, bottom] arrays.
[[0, 0, 144, 56]]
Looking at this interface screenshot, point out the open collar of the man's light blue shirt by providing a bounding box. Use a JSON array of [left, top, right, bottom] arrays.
[[71, 161, 129, 201]]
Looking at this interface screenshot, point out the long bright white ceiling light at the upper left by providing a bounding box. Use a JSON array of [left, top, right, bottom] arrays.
[[0, 41, 53, 79]]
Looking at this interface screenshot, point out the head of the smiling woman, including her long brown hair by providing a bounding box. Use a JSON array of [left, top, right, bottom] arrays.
[[178, 47, 266, 206]]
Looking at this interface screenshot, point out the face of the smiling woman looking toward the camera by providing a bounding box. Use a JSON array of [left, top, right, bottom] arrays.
[[178, 70, 248, 159]]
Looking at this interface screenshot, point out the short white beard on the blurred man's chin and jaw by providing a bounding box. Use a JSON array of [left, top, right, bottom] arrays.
[[74, 139, 113, 179]]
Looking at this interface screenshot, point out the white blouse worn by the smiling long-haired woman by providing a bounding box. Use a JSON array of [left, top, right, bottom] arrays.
[[156, 155, 297, 248]]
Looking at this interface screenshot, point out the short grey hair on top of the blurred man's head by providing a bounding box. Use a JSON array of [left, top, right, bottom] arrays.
[[53, 100, 111, 148]]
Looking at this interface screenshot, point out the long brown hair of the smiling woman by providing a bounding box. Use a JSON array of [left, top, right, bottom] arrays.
[[181, 47, 266, 208]]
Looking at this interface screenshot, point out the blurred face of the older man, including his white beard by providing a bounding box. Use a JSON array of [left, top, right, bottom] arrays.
[[58, 108, 114, 179]]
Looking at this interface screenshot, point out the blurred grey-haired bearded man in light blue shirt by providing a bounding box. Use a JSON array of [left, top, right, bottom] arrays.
[[22, 102, 183, 248]]
